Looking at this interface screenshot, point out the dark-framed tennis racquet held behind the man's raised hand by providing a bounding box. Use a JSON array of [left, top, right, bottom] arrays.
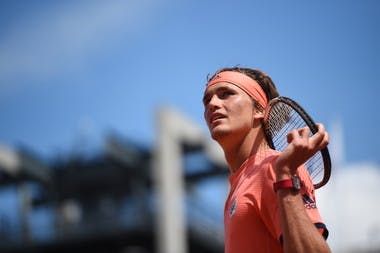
[[264, 97, 331, 189]]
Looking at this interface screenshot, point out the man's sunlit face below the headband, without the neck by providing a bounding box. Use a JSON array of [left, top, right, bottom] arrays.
[[203, 82, 253, 141]]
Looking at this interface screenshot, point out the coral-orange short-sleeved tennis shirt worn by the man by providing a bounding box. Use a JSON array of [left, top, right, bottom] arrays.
[[224, 149, 327, 253]]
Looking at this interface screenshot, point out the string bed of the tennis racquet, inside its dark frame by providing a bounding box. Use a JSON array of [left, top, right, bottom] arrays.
[[265, 101, 324, 187]]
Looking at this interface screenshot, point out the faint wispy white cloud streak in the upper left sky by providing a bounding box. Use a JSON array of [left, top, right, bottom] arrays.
[[0, 0, 169, 88]]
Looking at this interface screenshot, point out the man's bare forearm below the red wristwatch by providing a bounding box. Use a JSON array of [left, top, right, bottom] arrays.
[[277, 189, 330, 253]]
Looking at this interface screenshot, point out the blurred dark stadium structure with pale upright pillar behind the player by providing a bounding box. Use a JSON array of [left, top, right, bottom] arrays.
[[0, 109, 227, 253]]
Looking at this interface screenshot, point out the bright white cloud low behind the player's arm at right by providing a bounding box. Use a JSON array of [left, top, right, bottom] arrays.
[[317, 163, 380, 253]]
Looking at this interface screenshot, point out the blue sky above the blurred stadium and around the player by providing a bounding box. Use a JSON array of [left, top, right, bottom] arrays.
[[0, 0, 380, 163]]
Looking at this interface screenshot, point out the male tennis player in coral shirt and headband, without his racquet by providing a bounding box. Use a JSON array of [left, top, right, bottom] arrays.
[[203, 68, 330, 253]]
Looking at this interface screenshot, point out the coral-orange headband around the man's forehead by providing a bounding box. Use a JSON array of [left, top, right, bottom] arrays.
[[207, 71, 268, 108]]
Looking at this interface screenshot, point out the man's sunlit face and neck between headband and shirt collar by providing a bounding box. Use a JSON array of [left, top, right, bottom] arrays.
[[203, 82, 266, 172]]
